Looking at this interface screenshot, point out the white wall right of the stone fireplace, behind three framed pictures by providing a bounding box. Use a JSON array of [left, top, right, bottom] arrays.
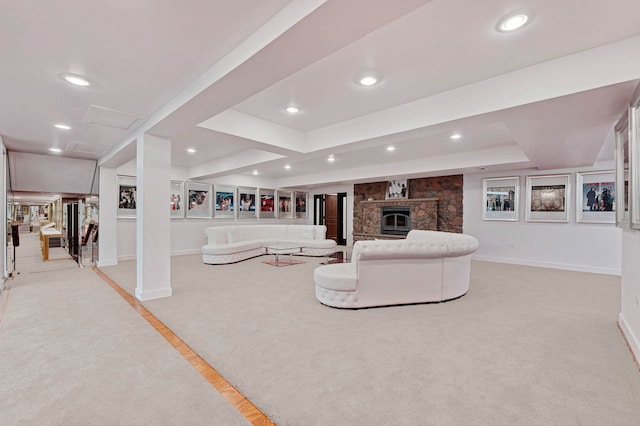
[[463, 164, 622, 275]]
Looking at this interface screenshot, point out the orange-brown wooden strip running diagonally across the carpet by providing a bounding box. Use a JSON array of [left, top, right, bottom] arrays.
[[93, 267, 275, 426]]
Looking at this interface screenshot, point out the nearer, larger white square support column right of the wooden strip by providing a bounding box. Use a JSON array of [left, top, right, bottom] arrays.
[[136, 135, 171, 301]]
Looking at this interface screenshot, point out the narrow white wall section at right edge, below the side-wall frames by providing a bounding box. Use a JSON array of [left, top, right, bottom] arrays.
[[619, 229, 640, 361]]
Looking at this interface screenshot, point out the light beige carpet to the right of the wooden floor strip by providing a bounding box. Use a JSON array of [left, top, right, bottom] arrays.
[[103, 250, 640, 425]]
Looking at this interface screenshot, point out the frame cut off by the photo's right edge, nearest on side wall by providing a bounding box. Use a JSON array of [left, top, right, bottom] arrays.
[[629, 85, 640, 229]]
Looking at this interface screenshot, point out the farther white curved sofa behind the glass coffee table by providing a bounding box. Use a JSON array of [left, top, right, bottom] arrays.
[[202, 225, 337, 265]]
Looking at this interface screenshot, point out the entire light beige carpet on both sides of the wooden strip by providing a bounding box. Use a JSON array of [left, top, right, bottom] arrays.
[[0, 233, 640, 425]]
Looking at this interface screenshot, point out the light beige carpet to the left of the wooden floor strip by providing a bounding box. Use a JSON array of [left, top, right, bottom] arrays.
[[0, 234, 247, 426]]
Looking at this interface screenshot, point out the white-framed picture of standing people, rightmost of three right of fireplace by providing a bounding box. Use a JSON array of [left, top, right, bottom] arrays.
[[576, 170, 616, 223]]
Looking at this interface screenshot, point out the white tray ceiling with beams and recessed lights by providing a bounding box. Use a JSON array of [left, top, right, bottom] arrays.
[[0, 0, 640, 203]]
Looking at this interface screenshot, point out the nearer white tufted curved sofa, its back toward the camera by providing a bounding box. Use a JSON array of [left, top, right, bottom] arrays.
[[314, 230, 478, 309]]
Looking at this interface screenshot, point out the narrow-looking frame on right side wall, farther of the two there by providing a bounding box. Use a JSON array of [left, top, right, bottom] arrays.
[[614, 110, 631, 228]]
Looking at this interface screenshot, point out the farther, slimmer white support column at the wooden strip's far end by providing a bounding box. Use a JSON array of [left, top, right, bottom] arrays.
[[96, 166, 118, 267]]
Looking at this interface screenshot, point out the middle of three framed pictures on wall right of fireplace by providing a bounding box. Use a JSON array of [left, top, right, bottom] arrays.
[[525, 174, 571, 222]]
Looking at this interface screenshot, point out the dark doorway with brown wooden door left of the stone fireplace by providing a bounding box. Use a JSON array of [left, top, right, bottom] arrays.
[[313, 192, 347, 245]]
